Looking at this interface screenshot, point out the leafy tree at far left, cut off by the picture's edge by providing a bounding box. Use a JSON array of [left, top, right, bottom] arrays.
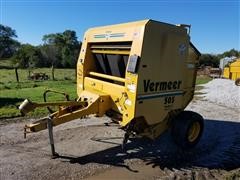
[[0, 24, 20, 58]]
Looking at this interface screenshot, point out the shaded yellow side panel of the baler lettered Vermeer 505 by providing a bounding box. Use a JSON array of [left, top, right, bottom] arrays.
[[136, 21, 198, 124]]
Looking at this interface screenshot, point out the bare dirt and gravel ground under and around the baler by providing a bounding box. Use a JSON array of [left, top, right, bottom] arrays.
[[0, 89, 240, 180]]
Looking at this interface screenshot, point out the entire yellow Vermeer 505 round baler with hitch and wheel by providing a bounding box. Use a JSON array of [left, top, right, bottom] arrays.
[[20, 20, 203, 155]]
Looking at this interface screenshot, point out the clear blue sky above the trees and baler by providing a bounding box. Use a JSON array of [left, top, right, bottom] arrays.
[[0, 0, 240, 53]]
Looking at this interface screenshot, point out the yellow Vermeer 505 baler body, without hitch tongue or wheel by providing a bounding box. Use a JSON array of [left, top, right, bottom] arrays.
[[77, 20, 200, 138]]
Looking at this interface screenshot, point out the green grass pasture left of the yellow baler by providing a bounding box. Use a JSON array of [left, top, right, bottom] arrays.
[[0, 68, 76, 118]]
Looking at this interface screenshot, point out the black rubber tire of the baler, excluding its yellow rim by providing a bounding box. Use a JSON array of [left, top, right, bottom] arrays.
[[171, 111, 204, 150]]
